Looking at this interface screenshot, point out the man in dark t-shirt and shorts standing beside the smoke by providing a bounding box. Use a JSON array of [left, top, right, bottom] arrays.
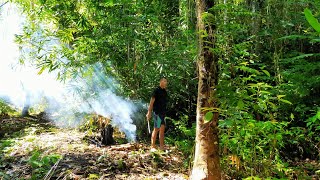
[[146, 77, 168, 150]]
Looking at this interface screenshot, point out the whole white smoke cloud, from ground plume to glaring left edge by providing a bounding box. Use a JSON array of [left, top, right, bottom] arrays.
[[0, 3, 137, 141]]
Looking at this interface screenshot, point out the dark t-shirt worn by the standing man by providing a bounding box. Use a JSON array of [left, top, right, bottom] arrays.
[[152, 87, 168, 115]]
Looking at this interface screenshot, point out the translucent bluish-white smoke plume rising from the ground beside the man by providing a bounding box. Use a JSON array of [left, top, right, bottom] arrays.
[[46, 63, 137, 141]]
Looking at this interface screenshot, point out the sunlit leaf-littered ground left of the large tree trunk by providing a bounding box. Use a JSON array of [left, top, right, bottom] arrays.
[[0, 118, 188, 179]]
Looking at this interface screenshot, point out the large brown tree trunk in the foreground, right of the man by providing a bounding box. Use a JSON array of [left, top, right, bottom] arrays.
[[191, 0, 221, 180]]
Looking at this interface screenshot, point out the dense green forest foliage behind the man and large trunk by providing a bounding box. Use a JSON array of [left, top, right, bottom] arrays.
[[0, 0, 320, 178]]
